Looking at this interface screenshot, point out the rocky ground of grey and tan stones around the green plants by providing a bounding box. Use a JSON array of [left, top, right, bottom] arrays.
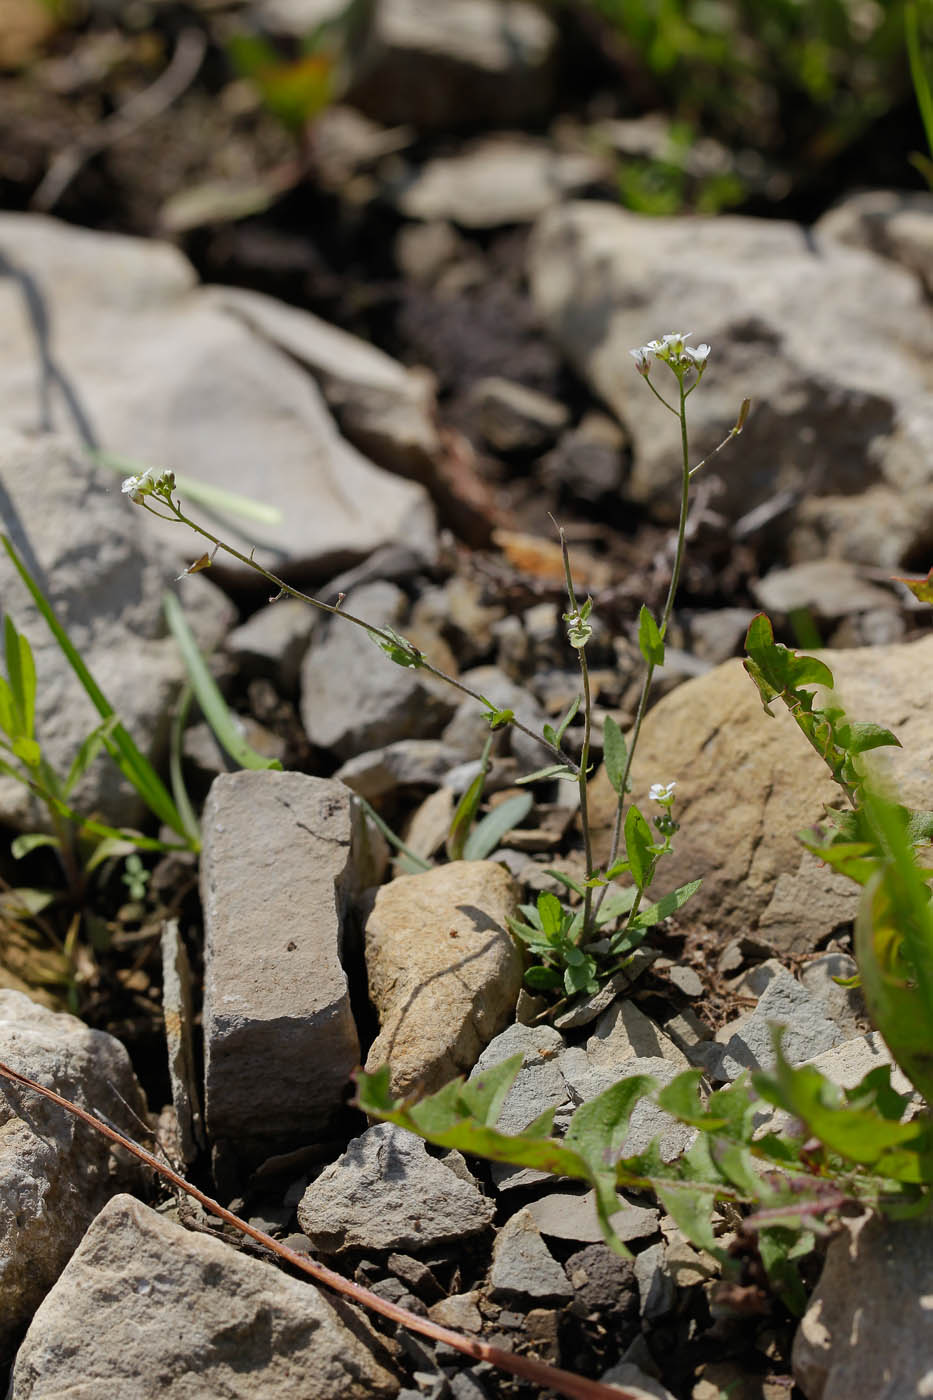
[[0, 0, 933, 1400]]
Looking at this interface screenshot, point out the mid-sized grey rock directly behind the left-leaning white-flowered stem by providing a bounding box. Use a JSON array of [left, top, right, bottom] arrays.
[[301, 582, 457, 759]]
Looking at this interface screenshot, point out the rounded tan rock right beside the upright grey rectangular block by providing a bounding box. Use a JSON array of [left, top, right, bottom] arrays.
[[366, 861, 521, 1093]]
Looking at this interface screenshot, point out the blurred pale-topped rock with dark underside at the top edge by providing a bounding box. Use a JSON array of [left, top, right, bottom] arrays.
[[347, 0, 558, 130]]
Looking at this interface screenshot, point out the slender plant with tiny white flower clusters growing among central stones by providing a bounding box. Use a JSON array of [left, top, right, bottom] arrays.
[[123, 332, 748, 998]]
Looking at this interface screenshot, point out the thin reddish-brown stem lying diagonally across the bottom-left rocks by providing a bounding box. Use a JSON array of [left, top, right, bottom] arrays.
[[0, 1061, 637, 1400]]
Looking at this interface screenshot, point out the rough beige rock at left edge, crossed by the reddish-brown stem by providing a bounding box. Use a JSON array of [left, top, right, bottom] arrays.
[[0, 990, 146, 1364]]
